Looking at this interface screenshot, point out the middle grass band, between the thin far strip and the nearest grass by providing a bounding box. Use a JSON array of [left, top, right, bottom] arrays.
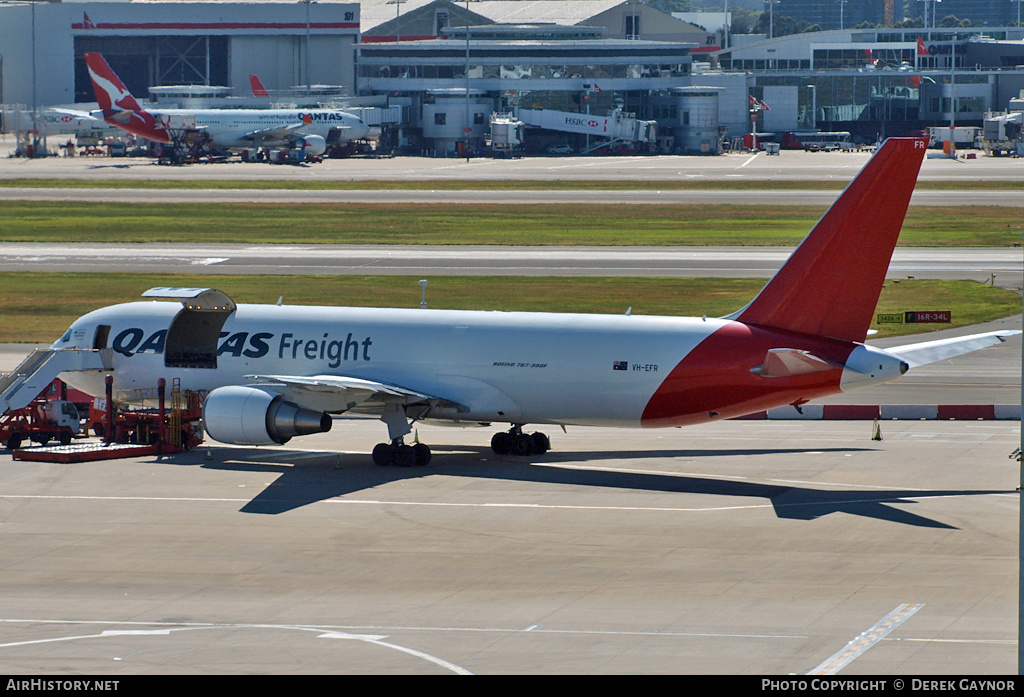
[[0, 201, 1021, 247]]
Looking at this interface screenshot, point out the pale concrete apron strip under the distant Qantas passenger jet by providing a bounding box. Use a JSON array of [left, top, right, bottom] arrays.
[[0, 138, 1024, 183]]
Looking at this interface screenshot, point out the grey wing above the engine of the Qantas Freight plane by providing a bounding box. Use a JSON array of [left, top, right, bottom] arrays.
[[246, 375, 460, 411]]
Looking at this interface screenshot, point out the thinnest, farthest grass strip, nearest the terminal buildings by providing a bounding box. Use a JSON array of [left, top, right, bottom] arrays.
[[0, 177, 1024, 191]]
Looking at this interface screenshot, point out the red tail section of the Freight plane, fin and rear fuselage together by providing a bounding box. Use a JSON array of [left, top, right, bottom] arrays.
[[642, 138, 927, 426]]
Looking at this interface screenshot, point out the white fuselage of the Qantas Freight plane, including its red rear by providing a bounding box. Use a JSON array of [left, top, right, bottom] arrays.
[[54, 302, 905, 427]]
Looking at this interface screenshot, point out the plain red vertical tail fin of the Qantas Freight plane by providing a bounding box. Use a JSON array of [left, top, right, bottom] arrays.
[[732, 138, 928, 342]]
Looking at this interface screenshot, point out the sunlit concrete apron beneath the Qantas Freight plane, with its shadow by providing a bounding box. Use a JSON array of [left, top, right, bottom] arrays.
[[0, 413, 1020, 677]]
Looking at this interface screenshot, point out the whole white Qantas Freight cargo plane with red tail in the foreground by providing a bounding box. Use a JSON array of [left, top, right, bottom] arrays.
[[9, 138, 1019, 465]]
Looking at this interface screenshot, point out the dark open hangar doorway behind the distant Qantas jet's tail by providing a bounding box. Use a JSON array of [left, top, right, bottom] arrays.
[[75, 36, 229, 101]]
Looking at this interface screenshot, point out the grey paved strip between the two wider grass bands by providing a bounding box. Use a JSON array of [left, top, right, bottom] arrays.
[[0, 243, 1024, 290]]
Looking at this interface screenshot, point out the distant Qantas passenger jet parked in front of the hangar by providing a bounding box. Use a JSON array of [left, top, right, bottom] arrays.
[[85, 53, 370, 155]]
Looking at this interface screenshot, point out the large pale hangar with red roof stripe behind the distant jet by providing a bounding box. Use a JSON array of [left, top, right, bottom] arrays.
[[0, 0, 359, 105]]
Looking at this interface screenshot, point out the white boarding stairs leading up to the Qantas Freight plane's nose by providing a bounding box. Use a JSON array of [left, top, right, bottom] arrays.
[[0, 348, 114, 416]]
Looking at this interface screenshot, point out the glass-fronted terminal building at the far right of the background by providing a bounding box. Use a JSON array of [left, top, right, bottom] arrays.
[[712, 27, 1024, 141]]
